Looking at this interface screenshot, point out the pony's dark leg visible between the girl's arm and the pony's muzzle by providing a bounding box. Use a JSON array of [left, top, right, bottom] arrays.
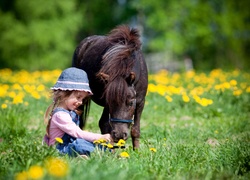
[[99, 108, 112, 134]]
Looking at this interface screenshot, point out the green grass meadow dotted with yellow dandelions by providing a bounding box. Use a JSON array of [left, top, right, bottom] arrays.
[[0, 70, 250, 179]]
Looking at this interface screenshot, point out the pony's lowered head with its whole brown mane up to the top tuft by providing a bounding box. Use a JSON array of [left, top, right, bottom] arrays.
[[97, 26, 141, 142]]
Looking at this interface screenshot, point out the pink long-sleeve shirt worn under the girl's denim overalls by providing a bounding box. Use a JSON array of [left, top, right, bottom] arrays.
[[44, 111, 102, 146]]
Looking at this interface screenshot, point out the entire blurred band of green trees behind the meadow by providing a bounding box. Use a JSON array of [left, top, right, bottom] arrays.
[[0, 0, 250, 70]]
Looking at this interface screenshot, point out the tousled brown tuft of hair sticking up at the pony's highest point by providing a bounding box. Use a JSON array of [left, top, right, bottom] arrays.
[[108, 25, 141, 50]]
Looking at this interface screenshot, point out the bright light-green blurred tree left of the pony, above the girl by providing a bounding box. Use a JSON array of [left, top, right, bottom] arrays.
[[0, 0, 82, 70]]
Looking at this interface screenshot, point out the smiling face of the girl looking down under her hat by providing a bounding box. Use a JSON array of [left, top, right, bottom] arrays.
[[61, 91, 88, 111]]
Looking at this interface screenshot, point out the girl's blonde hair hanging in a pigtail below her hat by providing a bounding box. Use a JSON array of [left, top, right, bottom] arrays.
[[44, 90, 74, 137]]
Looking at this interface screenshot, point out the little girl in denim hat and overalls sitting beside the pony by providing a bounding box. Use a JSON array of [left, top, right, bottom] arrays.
[[44, 67, 112, 156]]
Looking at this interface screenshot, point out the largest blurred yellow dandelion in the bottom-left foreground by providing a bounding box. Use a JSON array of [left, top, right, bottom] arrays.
[[45, 158, 69, 177]]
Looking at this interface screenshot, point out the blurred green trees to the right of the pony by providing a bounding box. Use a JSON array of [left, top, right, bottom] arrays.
[[131, 0, 250, 69]]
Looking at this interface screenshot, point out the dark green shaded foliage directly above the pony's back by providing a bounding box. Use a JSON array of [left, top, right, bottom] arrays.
[[74, 0, 136, 41]]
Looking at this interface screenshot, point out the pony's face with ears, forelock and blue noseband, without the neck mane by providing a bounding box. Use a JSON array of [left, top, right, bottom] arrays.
[[98, 72, 136, 142]]
